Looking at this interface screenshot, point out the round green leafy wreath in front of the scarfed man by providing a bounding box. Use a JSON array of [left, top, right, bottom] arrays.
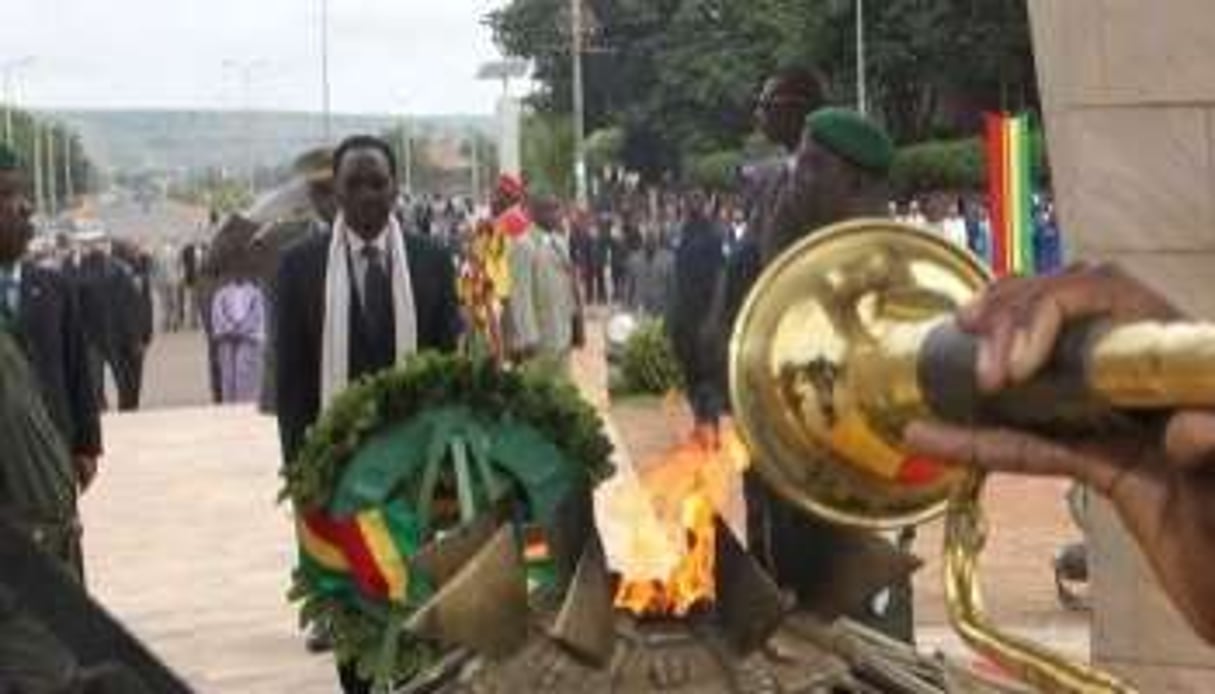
[[282, 354, 611, 682]]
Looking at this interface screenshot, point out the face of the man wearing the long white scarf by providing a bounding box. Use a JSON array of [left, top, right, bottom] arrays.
[[335, 147, 397, 239]]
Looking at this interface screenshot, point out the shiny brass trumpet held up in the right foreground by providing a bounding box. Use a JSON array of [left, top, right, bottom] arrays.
[[730, 219, 1215, 693]]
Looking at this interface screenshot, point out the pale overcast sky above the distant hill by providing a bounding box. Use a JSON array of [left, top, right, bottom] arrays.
[[0, 0, 503, 114]]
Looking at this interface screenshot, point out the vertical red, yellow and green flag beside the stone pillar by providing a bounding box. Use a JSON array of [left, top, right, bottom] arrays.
[[985, 113, 1035, 277]]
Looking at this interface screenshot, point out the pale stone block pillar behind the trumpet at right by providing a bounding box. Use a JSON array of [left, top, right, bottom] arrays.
[[1028, 0, 1215, 693]]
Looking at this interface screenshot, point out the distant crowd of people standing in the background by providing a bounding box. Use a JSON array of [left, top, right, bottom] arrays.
[[23, 168, 1063, 420]]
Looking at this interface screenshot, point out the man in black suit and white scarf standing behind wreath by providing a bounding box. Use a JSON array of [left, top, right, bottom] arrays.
[[275, 136, 459, 693]]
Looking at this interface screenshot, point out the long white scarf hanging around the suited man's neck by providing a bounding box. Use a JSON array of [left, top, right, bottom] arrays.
[[321, 215, 418, 407]]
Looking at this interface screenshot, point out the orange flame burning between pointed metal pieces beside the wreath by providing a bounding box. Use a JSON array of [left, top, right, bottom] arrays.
[[615, 425, 747, 617]]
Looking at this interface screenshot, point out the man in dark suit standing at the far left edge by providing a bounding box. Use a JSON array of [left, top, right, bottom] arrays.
[[0, 146, 101, 578]]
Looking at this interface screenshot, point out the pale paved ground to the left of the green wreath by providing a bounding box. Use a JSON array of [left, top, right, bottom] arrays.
[[83, 407, 335, 694]]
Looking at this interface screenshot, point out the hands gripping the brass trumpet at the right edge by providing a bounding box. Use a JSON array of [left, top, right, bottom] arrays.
[[905, 265, 1215, 643]]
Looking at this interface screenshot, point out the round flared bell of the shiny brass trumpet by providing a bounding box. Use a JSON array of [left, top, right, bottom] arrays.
[[730, 219, 990, 530]]
